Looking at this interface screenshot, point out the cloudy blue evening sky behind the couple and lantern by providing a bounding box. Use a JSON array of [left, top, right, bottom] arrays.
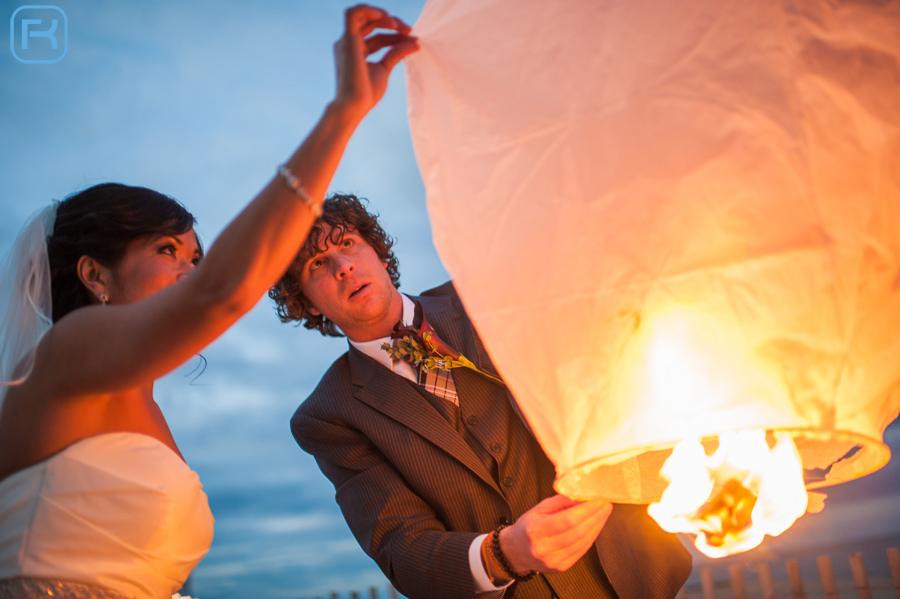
[[0, 0, 900, 599]]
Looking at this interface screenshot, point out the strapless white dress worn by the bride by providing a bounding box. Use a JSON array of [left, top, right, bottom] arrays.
[[0, 433, 213, 599]]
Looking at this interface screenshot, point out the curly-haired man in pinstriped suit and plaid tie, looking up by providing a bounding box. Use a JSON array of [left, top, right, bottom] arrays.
[[270, 195, 691, 599]]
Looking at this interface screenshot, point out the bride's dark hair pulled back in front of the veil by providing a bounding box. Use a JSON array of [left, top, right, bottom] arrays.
[[47, 183, 202, 322]]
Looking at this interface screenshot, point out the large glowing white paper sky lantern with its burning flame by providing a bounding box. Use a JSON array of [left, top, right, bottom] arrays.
[[406, 0, 900, 556]]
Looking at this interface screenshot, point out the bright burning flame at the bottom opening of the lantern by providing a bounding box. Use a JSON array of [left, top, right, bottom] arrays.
[[648, 430, 808, 558]]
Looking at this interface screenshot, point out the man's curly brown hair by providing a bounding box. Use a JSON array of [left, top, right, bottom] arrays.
[[269, 193, 400, 337]]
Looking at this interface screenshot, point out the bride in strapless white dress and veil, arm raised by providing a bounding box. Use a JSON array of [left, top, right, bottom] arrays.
[[0, 5, 417, 599]]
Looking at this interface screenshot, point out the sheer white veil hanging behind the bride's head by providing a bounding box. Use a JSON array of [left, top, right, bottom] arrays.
[[0, 202, 59, 406]]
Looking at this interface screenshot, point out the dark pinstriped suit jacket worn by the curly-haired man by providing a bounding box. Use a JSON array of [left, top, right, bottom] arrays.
[[291, 283, 691, 599]]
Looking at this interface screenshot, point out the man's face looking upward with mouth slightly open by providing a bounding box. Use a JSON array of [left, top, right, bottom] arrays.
[[300, 224, 403, 341]]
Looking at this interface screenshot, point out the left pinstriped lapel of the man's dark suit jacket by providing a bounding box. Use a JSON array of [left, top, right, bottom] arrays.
[[349, 341, 500, 493]]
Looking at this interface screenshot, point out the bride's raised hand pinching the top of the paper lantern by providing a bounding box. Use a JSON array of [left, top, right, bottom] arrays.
[[334, 4, 419, 119]]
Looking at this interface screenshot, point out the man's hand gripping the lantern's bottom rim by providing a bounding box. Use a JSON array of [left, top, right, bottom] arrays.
[[500, 495, 612, 574]]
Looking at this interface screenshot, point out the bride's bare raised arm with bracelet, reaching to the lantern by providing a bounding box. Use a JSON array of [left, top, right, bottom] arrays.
[[33, 6, 417, 397]]
